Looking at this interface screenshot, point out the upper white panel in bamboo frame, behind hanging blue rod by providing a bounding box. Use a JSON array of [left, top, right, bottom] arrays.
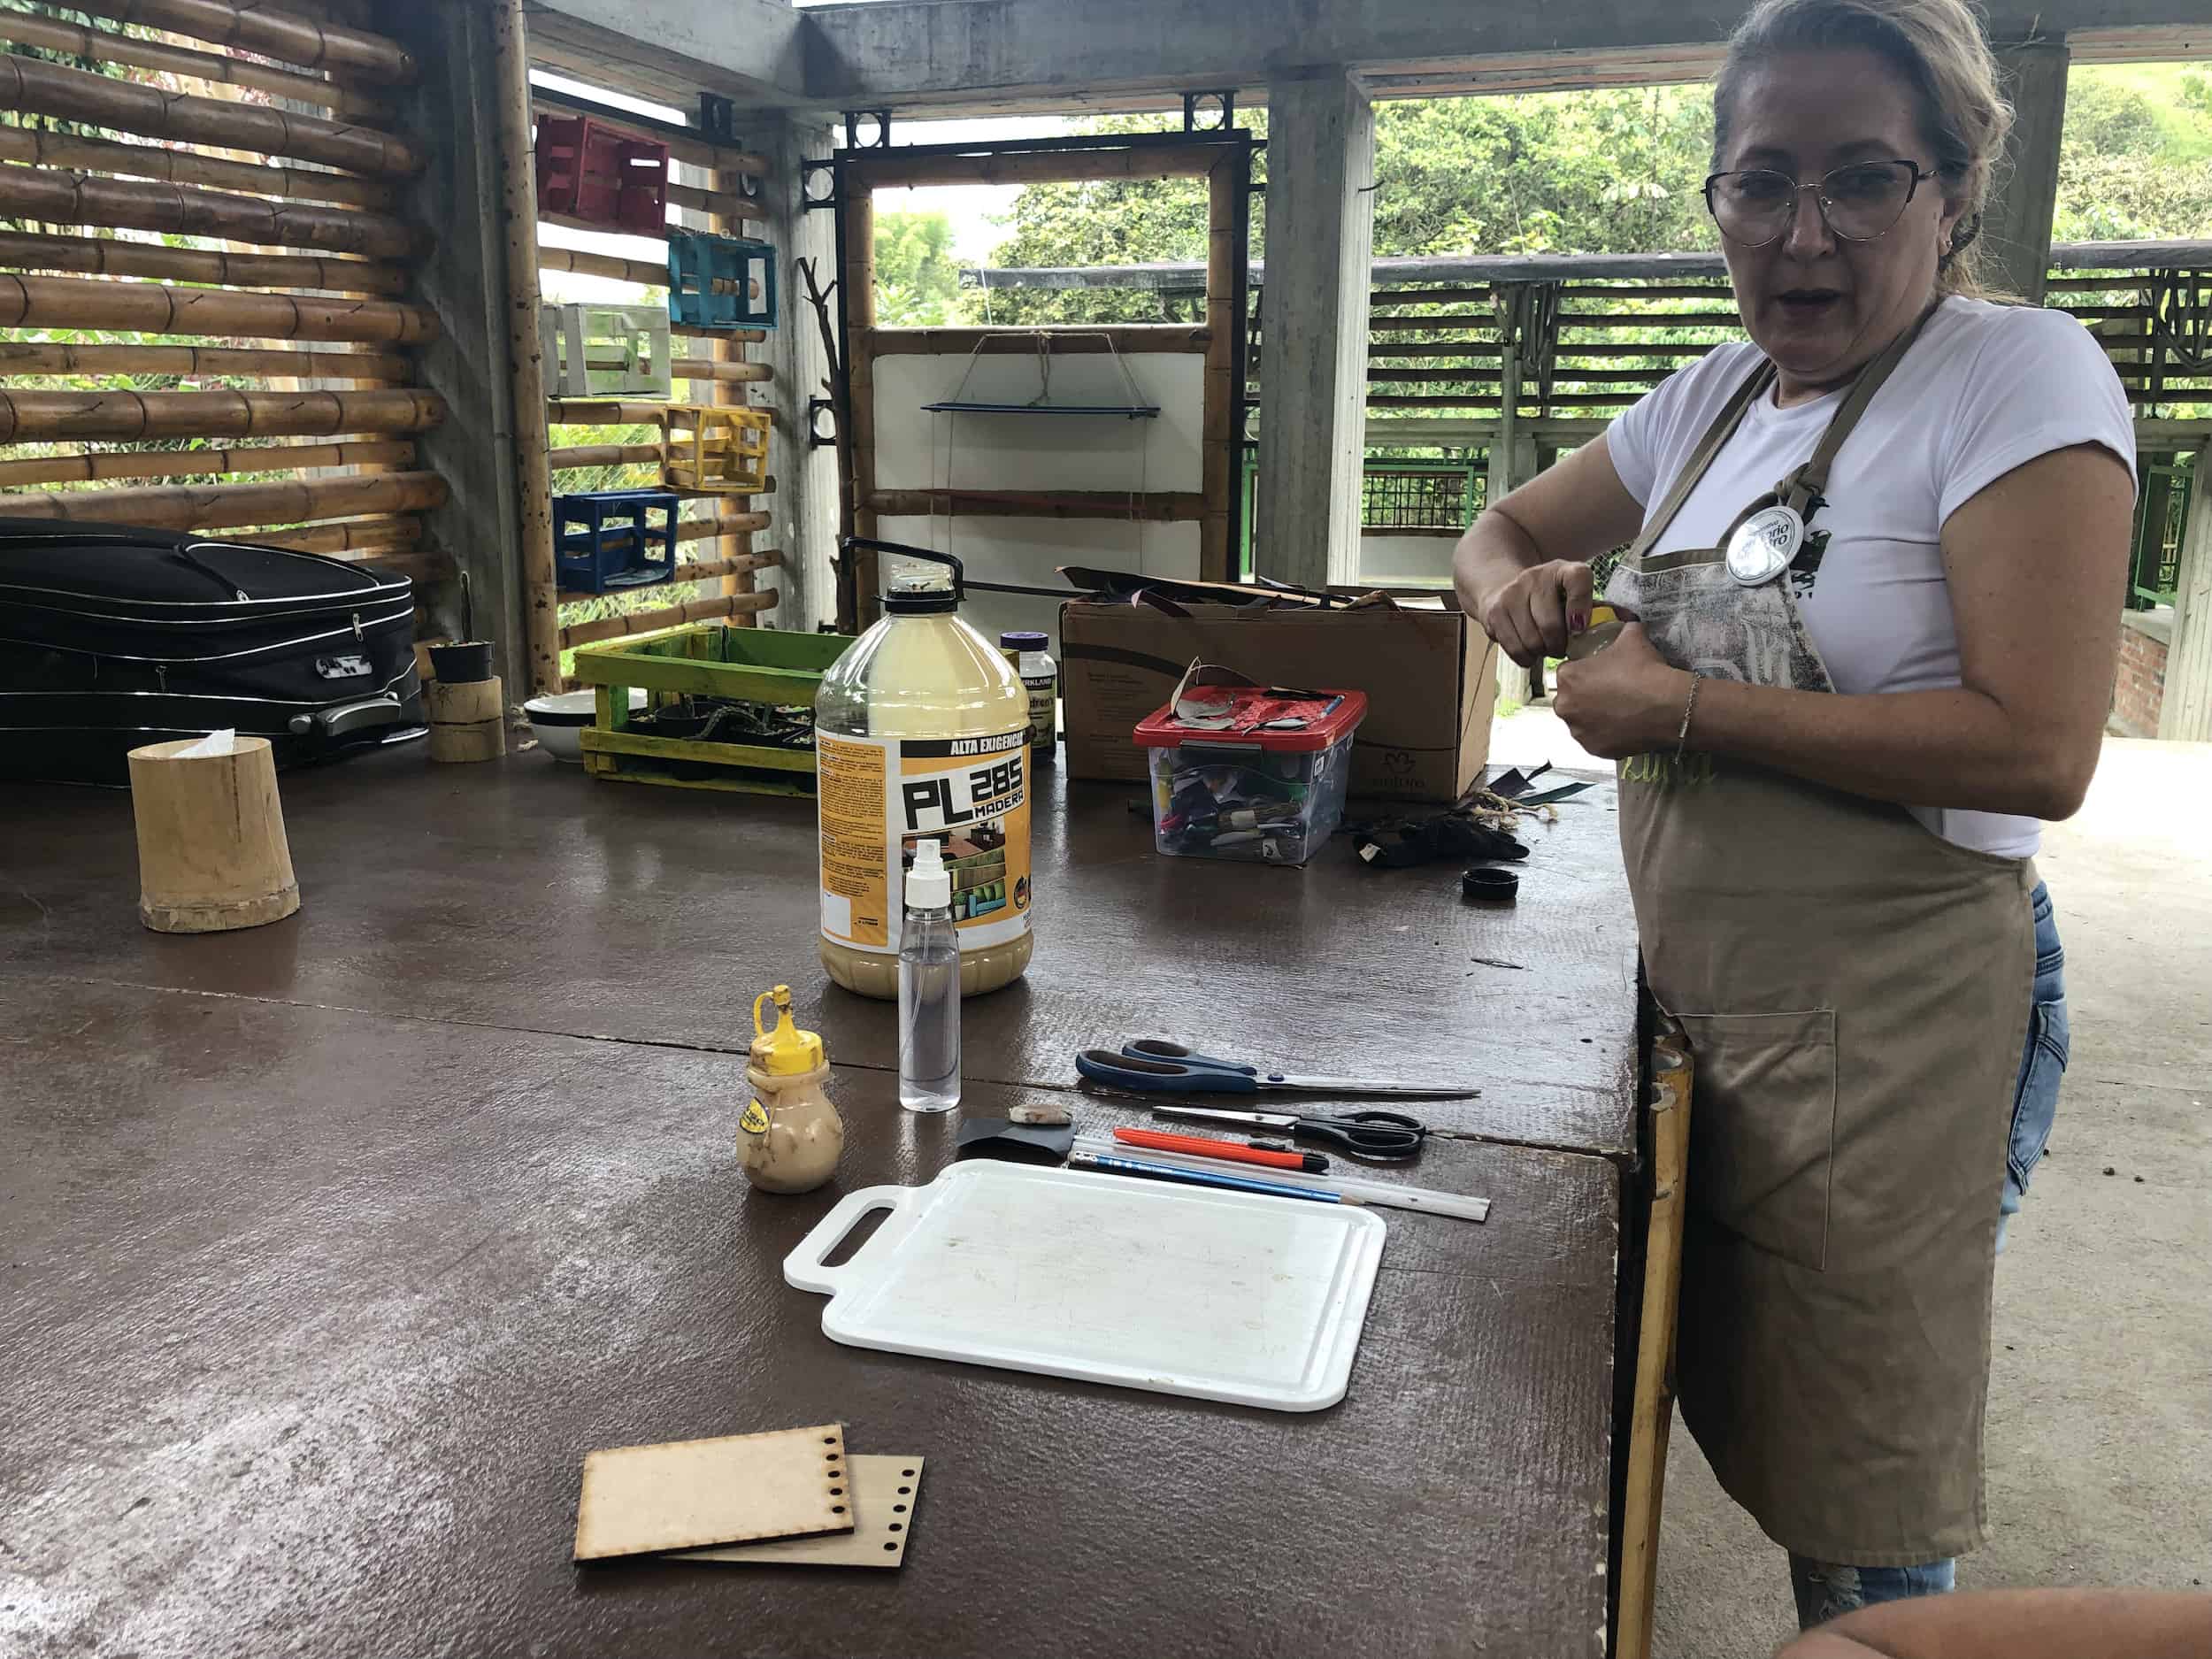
[[874, 352, 1206, 491]]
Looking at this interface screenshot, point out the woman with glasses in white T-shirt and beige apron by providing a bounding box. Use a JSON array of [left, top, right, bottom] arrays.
[[1455, 0, 2135, 1626]]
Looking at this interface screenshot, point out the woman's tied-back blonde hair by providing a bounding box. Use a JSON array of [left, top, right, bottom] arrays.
[[1712, 0, 2013, 299]]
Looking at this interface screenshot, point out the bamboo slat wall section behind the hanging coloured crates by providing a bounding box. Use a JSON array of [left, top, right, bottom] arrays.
[[531, 65, 783, 677]]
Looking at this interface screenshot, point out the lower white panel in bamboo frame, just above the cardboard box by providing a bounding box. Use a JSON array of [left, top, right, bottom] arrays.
[[876, 516, 1199, 657]]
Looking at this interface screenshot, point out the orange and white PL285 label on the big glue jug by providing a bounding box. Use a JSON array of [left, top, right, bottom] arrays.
[[814, 730, 1033, 956]]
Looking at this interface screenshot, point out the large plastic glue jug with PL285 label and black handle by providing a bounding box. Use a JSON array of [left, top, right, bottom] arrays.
[[814, 538, 1035, 1002]]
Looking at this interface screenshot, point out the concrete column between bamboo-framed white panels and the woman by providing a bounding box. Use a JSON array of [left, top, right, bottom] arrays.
[[1252, 69, 1374, 587]]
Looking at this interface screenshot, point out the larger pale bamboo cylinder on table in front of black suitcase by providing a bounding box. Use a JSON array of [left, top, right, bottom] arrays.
[[131, 737, 299, 933]]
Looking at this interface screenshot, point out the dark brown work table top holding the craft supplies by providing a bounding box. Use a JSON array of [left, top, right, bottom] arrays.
[[0, 748, 1635, 1655]]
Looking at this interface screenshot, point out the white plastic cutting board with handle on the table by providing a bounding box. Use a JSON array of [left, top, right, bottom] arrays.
[[783, 1164, 1385, 1411]]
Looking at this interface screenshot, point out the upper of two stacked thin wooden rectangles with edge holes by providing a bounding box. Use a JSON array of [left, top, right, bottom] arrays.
[[575, 1423, 854, 1562]]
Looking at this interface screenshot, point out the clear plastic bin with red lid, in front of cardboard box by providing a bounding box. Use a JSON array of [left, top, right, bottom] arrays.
[[1137, 664, 1367, 865]]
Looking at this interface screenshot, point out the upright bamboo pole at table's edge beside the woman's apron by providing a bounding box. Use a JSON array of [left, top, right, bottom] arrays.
[[1615, 1022, 1693, 1659]]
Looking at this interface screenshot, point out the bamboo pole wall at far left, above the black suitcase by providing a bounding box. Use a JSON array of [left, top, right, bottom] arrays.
[[0, 0, 451, 597]]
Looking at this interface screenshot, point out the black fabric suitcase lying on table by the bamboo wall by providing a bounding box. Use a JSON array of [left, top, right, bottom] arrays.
[[0, 518, 427, 783]]
